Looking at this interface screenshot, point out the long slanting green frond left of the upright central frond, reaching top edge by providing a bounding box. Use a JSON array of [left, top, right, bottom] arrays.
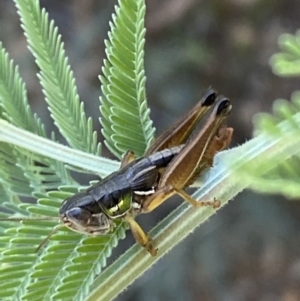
[[14, 0, 100, 154]]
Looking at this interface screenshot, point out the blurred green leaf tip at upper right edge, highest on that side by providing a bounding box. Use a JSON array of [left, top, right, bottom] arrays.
[[270, 30, 300, 76]]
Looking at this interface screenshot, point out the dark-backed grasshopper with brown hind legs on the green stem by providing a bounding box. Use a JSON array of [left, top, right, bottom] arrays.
[[1, 89, 233, 256]]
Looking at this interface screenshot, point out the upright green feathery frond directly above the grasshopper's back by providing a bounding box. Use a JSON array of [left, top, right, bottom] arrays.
[[100, 0, 154, 158]]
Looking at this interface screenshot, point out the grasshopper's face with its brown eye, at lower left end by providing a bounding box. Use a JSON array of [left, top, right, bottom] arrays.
[[61, 207, 113, 235]]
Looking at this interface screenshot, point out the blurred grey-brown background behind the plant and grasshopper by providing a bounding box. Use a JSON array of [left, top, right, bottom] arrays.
[[0, 0, 300, 301]]
